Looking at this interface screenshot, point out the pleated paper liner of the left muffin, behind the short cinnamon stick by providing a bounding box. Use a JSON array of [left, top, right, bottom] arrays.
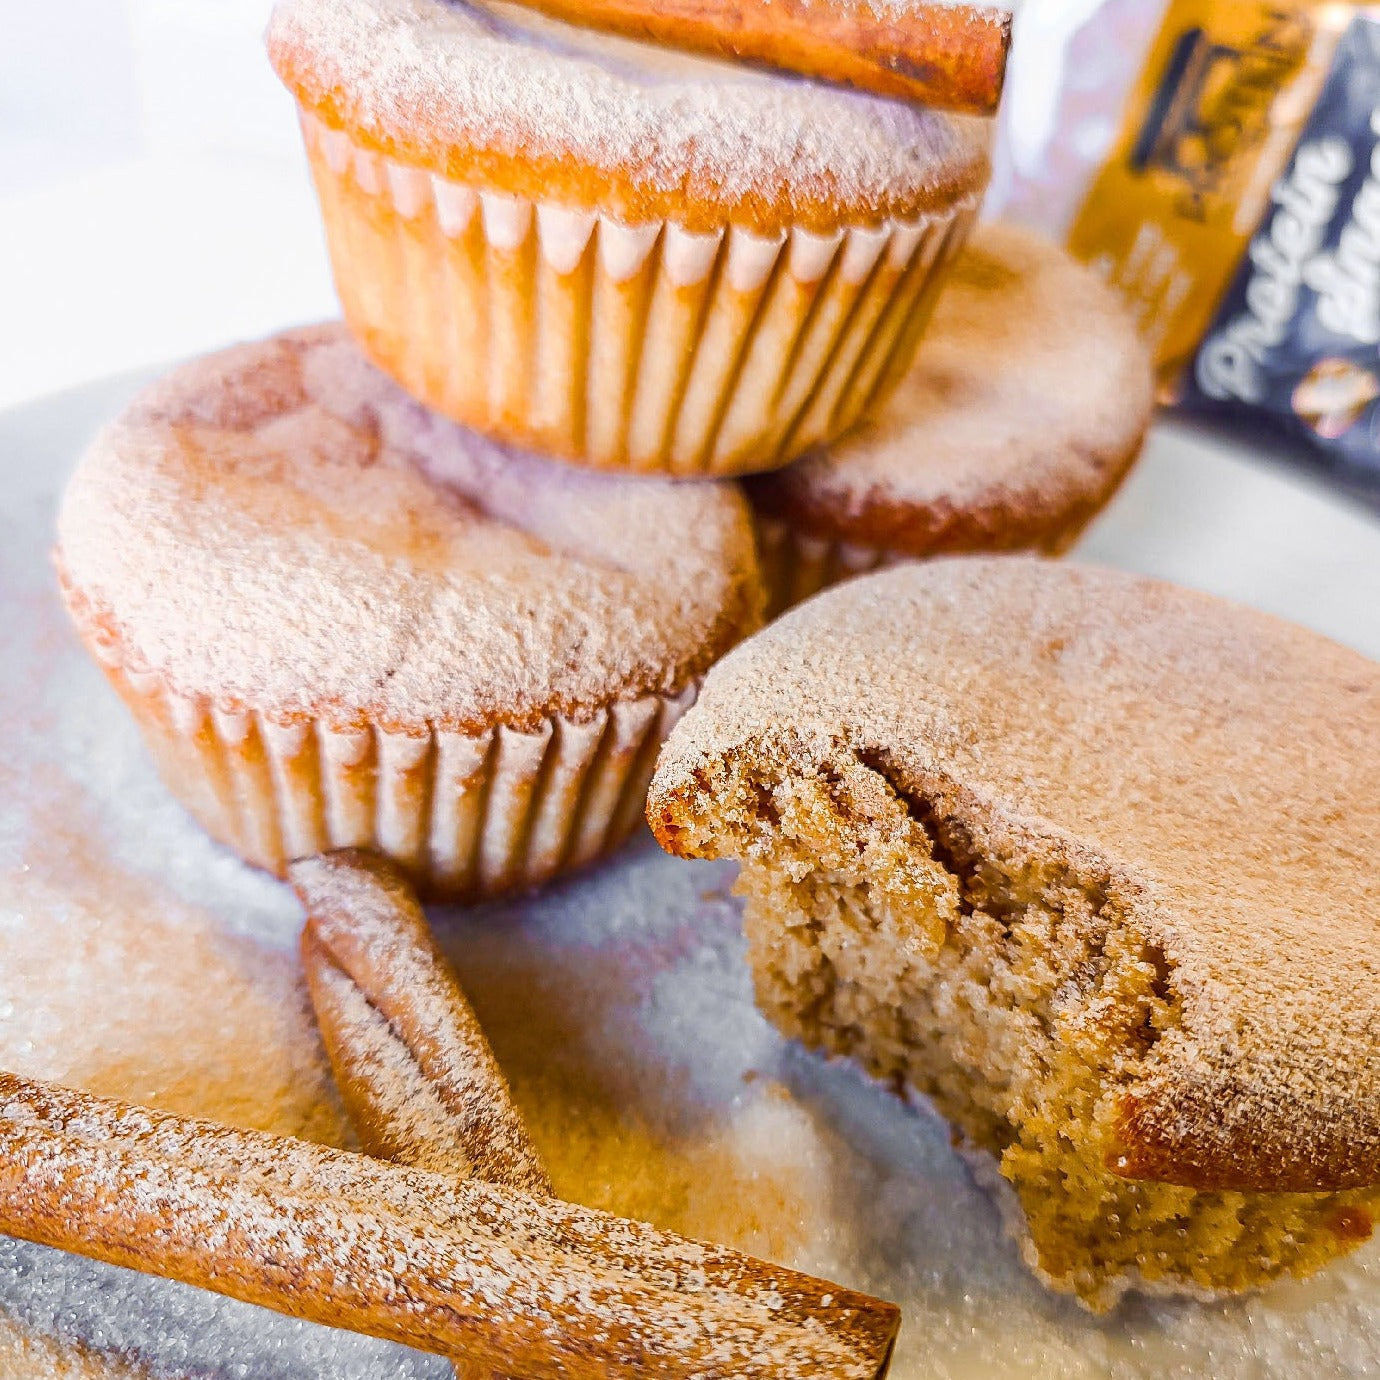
[[87, 638, 697, 901]]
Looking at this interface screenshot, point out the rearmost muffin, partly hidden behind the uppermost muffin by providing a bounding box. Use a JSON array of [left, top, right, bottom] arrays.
[[748, 225, 1154, 610]]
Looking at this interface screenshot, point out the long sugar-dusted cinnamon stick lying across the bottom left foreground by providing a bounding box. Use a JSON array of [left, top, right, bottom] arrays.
[[0, 1074, 898, 1380]]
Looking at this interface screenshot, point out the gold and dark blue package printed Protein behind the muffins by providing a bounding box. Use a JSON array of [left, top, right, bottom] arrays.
[[995, 0, 1380, 498]]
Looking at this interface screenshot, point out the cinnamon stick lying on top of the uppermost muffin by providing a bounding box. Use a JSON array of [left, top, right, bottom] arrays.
[[507, 0, 1012, 115]]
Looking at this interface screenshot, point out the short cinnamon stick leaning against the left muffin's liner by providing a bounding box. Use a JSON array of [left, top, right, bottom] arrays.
[[288, 850, 551, 1194]]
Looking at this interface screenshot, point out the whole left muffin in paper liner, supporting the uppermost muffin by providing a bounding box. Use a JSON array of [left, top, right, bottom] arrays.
[[57, 326, 762, 897]]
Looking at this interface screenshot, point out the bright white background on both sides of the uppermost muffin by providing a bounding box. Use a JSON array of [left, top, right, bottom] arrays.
[[0, 0, 1165, 407]]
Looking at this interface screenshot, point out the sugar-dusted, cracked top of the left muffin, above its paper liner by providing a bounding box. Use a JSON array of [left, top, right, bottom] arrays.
[[58, 324, 760, 733]]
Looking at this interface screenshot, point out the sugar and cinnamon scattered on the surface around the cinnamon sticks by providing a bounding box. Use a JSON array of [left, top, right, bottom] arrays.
[[0, 372, 1380, 1380]]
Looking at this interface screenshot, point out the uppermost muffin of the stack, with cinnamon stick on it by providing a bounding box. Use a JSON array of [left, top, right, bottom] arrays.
[[268, 0, 988, 475]]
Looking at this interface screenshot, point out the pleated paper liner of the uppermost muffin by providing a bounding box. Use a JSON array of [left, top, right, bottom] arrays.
[[302, 113, 976, 476]]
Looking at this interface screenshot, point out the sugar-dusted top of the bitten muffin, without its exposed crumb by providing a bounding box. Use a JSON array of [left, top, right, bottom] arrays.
[[649, 558, 1380, 1191]]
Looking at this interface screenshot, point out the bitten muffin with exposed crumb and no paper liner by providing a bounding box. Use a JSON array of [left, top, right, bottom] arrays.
[[649, 558, 1380, 1310]]
